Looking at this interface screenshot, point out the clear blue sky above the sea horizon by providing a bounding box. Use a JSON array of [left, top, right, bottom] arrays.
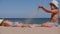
[[0, 0, 60, 18]]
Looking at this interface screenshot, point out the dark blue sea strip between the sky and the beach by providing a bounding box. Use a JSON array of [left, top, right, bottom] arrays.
[[1, 18, 60, 24]]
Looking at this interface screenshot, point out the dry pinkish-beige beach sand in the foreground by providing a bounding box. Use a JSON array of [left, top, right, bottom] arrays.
[[0, 26, 60, 34]]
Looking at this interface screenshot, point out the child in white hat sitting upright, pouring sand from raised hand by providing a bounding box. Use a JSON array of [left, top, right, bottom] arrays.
[[39, 0, 59, 27]]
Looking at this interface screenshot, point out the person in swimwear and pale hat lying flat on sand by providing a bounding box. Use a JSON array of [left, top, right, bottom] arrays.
[[0, 19, 31, 28]]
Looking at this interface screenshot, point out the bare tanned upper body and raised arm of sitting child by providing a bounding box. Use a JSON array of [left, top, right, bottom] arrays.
[[39, 6, 59, 23]]
